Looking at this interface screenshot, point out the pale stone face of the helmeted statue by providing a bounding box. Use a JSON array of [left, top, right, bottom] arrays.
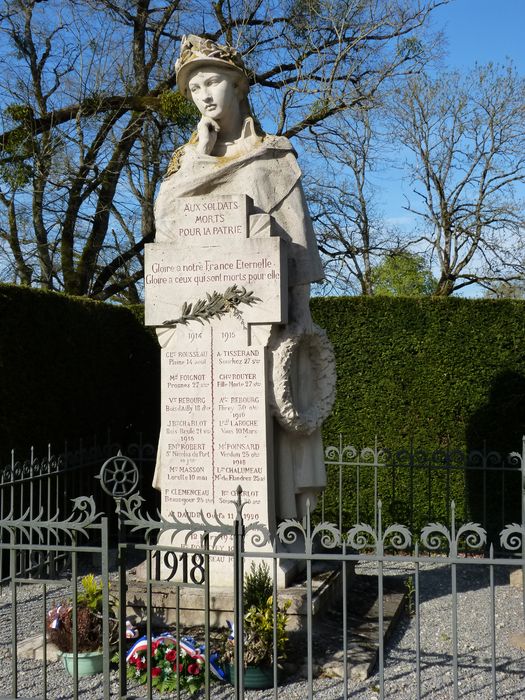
[[188, 67, 239, 122]]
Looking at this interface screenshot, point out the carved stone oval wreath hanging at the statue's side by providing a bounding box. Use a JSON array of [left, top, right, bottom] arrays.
[[270, 324, 336, 435]]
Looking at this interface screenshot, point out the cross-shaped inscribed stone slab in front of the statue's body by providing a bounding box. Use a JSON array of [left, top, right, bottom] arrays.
[[145, 195, 287, 589]]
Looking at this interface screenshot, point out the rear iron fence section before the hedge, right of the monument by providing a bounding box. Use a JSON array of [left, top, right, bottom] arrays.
[[316, 437, 525, 548]]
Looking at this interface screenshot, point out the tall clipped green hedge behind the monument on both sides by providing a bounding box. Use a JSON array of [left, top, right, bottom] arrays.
[[0, 285, 525, 522]]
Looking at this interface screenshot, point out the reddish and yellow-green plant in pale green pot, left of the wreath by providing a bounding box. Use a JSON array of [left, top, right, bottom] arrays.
[[47, 574, 118, 676]]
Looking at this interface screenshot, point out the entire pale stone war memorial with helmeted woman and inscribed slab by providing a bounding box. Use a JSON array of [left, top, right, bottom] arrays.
[[145, 35, 335, 586]]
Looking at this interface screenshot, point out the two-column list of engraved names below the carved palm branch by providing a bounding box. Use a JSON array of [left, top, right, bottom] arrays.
[[161, 324, 267, 520]]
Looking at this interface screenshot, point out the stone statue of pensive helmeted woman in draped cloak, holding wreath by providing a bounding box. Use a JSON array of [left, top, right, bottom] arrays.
[[155, 35, 335, 518]]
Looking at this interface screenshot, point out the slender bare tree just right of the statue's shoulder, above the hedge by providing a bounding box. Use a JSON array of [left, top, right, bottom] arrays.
[[307, 110, 407, 296]]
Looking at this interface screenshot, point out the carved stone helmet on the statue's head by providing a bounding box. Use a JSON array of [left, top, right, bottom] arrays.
[[175, 34, 250, 98]]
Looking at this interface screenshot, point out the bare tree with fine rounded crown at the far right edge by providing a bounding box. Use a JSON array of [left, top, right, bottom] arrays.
[[393, 65, 525, 296]]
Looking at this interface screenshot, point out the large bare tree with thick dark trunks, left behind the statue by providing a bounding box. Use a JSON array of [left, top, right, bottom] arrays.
[[0, 0, 446, 300]]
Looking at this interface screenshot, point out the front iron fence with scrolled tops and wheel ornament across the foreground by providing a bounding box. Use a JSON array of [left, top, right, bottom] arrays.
[[0, 455, 525, 700]]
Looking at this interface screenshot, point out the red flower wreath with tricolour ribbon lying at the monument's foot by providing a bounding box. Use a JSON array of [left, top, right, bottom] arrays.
[[126, 632, 224, 695]]
